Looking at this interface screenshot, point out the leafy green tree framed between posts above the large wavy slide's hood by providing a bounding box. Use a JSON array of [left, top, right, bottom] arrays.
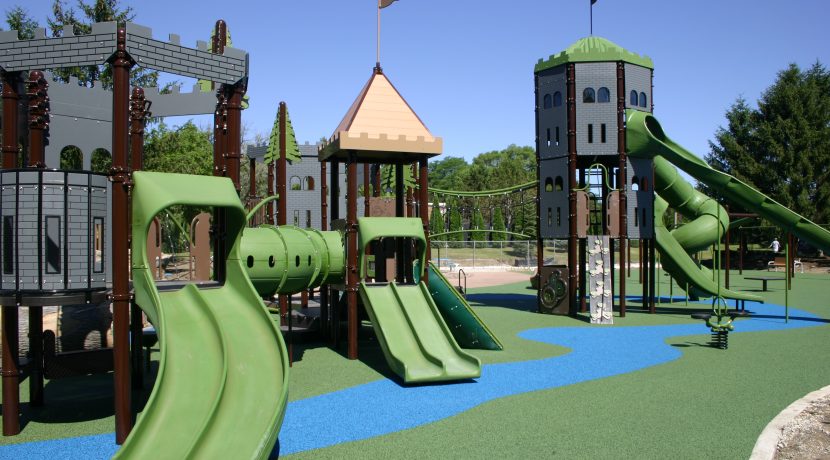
[[144, 121, 213, 176]]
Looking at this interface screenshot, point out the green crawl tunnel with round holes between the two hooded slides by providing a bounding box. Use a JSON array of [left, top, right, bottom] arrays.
[[240, 225, 345, 296]]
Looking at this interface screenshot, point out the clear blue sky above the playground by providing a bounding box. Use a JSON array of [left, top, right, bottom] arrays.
[[11, 0, 830, 160]]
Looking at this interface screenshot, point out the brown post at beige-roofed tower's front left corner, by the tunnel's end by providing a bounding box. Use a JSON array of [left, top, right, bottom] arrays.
[[346, 152, 359, 359]]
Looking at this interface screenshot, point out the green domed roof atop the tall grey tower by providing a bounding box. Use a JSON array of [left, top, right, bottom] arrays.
[[533, 36, 654, 72]]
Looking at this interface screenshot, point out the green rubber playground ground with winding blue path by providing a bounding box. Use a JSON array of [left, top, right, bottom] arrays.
[[0, 271, 830, 458]]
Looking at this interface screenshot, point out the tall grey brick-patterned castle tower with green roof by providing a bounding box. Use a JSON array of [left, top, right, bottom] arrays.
[[534, 36, 654, 316]]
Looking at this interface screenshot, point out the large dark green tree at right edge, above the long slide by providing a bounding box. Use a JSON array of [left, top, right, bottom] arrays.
[[701, 63, 830, 223]]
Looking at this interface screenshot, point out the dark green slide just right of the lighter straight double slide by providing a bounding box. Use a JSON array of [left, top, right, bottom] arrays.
[[415, 262, 504, 350]]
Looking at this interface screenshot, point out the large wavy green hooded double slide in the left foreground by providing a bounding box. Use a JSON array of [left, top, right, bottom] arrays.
[[116, 172, 288, 459]]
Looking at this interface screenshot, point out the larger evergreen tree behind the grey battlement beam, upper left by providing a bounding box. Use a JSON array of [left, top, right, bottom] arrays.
[[46, 0, 158, 88]]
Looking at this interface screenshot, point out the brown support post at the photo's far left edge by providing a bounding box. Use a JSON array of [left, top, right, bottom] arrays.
[[2, 72, 20, 436]]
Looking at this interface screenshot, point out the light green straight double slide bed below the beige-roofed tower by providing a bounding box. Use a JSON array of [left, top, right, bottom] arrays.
[[360, 282, 481, 383]]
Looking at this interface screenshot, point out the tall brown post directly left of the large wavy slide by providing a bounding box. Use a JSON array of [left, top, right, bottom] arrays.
[[110, 28, 133, 444]]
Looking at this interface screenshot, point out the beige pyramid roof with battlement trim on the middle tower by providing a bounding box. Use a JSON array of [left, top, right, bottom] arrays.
[[320, 67, 443, 162]]
